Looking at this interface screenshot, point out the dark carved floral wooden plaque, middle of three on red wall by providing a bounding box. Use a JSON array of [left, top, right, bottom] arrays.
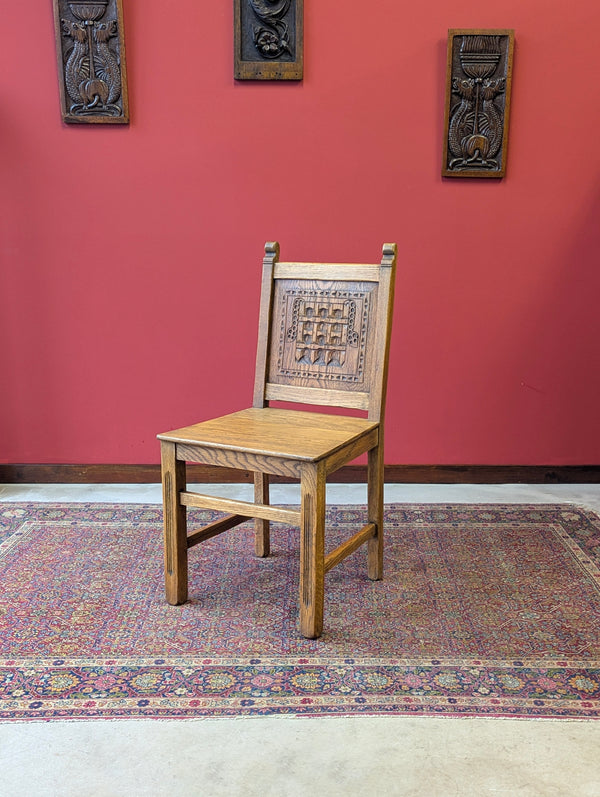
[[233, 0, 304, 80]]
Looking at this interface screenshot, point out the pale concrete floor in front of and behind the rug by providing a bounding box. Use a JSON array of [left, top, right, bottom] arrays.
[[0, 478, 600, 797]]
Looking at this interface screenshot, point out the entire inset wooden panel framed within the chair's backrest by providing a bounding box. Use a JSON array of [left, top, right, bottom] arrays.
[[268, 280, 377, 391]]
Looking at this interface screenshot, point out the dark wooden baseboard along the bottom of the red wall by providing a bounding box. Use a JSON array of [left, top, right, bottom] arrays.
[[0, 464, 600, 484]]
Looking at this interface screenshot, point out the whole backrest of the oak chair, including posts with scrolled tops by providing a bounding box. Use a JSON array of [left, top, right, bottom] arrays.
[[253, 241, 397, 421]]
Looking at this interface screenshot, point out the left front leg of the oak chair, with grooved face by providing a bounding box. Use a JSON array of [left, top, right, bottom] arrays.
[[160, 440, 188, 606]]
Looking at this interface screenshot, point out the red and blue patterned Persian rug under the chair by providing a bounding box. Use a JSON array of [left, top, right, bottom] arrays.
[[0, 503, 600, 721]]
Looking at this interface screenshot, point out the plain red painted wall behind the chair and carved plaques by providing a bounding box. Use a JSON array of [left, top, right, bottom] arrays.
[[0, 0, 600, 465]]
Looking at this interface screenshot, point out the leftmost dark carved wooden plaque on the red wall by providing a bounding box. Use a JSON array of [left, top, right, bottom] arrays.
[[54, 0, 129, 124]]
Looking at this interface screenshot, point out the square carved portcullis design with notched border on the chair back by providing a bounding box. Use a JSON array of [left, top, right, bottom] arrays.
[[277, 289, 370, 382]]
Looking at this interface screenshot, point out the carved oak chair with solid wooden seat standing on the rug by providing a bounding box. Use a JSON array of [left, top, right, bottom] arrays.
[[158, 242, 397, 639]]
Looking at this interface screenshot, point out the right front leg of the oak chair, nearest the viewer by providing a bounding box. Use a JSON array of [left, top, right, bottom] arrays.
[[300, 464, 325, 639]]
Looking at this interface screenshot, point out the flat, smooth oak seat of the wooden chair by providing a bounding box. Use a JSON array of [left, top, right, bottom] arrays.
[[158, 407, 379, 462]]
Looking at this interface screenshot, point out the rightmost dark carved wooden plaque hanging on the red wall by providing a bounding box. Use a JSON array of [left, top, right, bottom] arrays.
[[442, 30, 514, 177]]
